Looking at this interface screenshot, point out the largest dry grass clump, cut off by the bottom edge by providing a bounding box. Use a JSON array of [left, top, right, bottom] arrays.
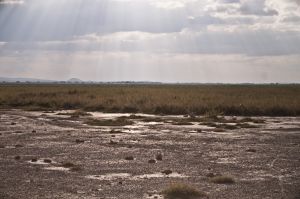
[[162, 183, 207, 199]]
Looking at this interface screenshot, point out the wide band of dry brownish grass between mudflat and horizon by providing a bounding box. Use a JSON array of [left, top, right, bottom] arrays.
[[0, 84, 300, 116]]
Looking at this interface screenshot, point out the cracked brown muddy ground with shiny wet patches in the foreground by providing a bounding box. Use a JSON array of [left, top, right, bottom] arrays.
[[0, 110, 300, 199]]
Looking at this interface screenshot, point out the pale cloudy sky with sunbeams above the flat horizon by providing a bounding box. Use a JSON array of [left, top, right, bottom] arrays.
[[0, 0, 300, 83]]
